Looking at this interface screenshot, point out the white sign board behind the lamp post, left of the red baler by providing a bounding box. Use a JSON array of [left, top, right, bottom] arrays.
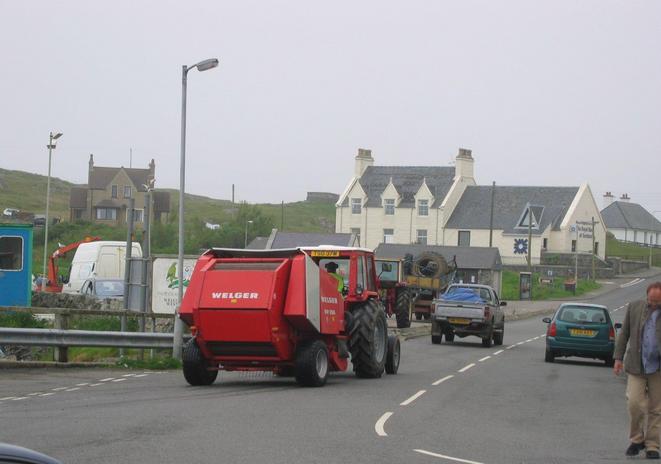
[[151, 258, 197, 314]]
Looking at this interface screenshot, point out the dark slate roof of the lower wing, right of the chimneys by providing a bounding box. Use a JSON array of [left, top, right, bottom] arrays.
[[447, 186, 578, 235]]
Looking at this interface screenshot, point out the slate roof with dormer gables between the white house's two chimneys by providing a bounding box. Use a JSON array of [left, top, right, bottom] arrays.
[[342, 166, 455, 208]]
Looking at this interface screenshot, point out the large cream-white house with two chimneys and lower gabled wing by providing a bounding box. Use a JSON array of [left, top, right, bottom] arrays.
[[335, 149, 606, 264]]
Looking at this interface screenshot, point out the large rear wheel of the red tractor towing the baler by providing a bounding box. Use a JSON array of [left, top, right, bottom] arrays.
[[349, 300, 388, 378]]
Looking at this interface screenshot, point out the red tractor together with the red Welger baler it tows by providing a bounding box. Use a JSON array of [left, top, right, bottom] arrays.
[[179, 247, 400, 387]]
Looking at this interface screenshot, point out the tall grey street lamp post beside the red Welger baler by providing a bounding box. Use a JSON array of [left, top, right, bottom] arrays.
[[172, 58, 218, 359]]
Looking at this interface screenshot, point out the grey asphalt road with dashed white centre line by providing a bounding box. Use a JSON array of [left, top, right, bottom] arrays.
[[0, 272, 655, 464]]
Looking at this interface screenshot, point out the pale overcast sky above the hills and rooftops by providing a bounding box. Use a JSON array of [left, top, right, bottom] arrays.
[[0, 0, 661, 213]]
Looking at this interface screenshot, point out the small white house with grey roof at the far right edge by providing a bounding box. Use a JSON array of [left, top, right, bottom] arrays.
[[601, 197, 661, 246]]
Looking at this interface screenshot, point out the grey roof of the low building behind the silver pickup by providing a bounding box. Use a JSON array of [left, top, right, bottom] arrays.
[[374, 243, 502, 270]]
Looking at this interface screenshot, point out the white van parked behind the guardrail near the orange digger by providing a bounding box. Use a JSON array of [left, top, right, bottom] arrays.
[[62, 241, 142, 293]]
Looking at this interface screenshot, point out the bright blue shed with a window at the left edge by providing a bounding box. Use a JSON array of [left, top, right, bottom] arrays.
[[0, 224, 32, 306]]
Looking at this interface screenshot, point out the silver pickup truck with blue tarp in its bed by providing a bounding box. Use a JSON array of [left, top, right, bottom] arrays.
[[431, 284, 507, 348]]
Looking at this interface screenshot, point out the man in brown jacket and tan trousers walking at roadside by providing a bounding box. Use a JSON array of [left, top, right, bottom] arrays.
[[613, 282, 661, 459]]
